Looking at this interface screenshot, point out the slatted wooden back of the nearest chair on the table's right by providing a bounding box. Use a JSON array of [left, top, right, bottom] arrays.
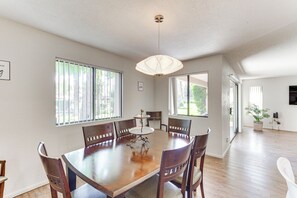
[[157, 141, 193, 198]]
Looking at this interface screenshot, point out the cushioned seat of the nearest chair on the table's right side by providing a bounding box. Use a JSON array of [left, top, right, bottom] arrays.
[[125, 175, 183, 198]]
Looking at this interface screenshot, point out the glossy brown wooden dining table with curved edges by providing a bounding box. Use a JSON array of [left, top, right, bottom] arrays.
[[62, 130, 190, 197]]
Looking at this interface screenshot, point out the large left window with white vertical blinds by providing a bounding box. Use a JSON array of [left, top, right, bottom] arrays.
[[56, 59, 122, 125]]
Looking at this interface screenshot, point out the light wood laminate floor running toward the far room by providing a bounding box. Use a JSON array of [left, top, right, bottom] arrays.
[[18, 128, 297, 198]]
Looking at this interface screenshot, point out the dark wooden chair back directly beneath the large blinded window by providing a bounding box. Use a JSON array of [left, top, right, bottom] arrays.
[[82, 122, 114, 147]]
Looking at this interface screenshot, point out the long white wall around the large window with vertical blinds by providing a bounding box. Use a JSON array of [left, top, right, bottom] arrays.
[[0, 18, 154, 197]]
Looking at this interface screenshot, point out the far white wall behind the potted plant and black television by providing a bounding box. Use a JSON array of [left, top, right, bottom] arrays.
[[242, 76, 297, 132]]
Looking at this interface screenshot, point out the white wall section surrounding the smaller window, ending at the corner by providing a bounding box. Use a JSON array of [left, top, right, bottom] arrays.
[[155, 55, 229, 157]]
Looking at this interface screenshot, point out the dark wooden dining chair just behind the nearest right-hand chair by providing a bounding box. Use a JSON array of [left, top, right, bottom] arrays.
[[172, 129, 210, 198]]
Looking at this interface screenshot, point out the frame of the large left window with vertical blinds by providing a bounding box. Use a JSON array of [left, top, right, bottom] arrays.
[[55, 57, 124, 127]]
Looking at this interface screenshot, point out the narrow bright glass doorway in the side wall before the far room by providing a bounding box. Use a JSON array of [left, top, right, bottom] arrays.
[[229, 80, 238, 143]]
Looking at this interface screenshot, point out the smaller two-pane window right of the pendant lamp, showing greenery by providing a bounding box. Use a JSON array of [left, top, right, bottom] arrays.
[[169, 73, 208, 116]]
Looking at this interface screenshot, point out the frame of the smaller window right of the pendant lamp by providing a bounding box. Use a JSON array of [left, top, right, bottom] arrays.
[[168, 71, 209, 118]]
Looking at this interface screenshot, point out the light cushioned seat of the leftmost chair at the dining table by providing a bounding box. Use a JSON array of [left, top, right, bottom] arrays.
[[71, 184, 107, 198]]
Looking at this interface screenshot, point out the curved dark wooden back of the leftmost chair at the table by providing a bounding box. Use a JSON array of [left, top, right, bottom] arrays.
[[37, 142, 71, 198]]
